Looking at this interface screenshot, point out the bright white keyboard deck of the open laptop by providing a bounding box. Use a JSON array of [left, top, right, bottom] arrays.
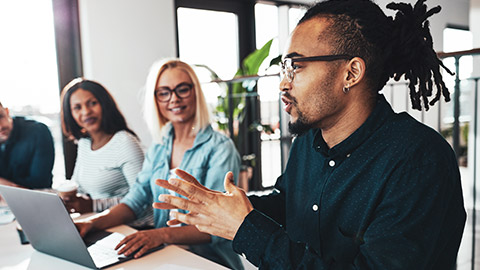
[[88, 232, 127, 267]]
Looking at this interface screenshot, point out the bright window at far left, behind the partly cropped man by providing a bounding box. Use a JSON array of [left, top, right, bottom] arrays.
[[0, 0, 65, 181]]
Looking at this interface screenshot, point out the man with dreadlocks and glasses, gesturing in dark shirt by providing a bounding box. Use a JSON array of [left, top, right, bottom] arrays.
[[154, 0, 466, 269]]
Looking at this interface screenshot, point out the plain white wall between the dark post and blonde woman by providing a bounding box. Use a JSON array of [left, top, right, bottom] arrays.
[[79, 0, 176, 147]]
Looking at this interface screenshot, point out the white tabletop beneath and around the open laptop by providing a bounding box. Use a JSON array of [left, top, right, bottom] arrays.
[[0, 219, 227, 270]]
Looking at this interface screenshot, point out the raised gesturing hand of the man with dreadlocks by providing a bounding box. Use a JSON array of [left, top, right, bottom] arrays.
[[153, 169, 253, 240]]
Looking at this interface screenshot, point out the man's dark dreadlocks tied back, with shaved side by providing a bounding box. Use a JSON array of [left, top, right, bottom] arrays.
[[298, 0, 454, 111]]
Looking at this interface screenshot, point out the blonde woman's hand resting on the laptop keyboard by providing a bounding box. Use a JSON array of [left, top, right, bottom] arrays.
[[115, 229, 164, 259]]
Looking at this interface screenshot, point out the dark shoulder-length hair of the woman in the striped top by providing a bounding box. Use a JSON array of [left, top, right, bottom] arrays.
[[60, 78, 138, 140]]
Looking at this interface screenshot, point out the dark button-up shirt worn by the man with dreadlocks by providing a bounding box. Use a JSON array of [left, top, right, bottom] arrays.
[[233, 96, 466, 269]]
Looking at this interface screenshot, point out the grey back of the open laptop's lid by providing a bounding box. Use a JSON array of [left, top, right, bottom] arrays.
[[0, 185, 109, 268]]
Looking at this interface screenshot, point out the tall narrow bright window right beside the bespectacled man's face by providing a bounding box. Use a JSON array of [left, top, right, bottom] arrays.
[[255, 4, 305, 188]]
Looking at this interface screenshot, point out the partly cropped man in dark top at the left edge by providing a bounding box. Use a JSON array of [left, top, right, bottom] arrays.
[[0, 103, 55, 188]]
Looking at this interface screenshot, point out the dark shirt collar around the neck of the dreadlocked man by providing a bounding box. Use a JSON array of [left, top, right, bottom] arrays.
[[312, 95, 394, 158]]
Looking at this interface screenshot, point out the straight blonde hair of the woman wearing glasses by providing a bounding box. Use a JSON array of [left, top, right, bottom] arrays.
[[143, 59, 210, 143]]
